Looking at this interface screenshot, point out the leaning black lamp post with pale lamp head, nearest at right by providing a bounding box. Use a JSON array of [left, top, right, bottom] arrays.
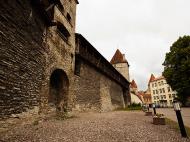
[[174, 100, 187, 137]]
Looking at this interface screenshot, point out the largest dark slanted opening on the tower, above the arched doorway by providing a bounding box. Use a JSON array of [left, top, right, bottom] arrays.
[[57, 22, 70, 42]]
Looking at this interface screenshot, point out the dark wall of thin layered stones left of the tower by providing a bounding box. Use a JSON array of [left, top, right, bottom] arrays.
[[0, 0, 48, 117]]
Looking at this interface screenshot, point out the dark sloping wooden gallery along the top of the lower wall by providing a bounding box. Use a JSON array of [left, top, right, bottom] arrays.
[[75, 33, 129, 90]]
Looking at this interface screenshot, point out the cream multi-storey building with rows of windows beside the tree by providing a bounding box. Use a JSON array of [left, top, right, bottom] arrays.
[[148, 74, 176, 107]]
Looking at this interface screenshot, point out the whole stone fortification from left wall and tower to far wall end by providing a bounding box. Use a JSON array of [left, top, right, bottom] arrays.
[[0, 0, 129, 118]]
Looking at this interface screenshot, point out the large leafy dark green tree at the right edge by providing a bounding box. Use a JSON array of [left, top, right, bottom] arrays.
[[163, 36, 190, 105]]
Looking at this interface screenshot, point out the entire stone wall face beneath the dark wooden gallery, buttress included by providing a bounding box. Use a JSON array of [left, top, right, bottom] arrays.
[[76, 61, 124, 112]]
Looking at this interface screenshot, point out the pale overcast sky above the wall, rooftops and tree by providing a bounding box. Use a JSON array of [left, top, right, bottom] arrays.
[[76, 0, 190, 90]]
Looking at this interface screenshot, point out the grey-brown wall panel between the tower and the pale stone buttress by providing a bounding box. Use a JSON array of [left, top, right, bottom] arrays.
[[76, 63, 101, 111]]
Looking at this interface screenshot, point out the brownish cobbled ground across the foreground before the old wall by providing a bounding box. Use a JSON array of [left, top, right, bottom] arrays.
[[0, 111, 190, 142]]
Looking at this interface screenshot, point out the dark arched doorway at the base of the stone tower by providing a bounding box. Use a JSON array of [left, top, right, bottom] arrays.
[[48, 69, 69, 111]]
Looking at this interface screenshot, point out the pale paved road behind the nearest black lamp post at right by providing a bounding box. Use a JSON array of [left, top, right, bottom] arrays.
[[157, 108, 190, 127]]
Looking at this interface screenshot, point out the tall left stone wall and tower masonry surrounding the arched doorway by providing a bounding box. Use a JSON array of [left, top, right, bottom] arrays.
[[0, 0, 76, 118]]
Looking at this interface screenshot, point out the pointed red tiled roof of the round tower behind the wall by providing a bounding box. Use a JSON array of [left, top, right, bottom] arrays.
[[110, 49, 128, 64]]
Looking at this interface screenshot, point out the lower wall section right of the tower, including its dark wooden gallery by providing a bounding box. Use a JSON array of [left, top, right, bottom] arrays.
[[75, 34, 129, 111]]
